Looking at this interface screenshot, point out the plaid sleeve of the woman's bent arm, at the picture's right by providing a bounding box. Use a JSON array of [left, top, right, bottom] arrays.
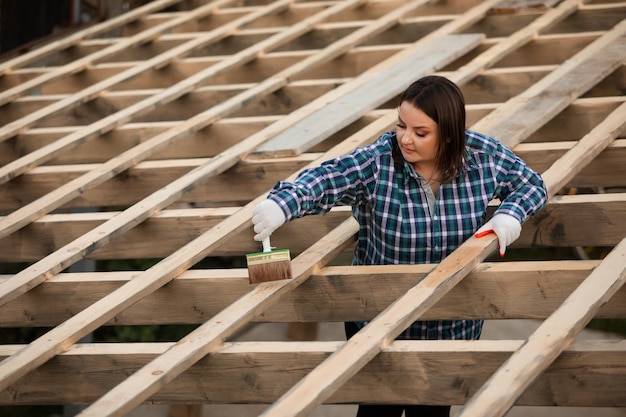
[[496, 136, 548, 223]]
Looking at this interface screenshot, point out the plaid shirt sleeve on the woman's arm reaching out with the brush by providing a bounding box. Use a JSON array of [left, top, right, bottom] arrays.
[[268, 135, 386, 220]]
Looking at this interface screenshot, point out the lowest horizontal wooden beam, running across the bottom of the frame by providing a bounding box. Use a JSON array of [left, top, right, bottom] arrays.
[[0, 339, 626, 404]]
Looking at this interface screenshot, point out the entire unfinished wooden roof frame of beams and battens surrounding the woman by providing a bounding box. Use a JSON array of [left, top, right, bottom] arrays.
[[0, 0, 626, 416]]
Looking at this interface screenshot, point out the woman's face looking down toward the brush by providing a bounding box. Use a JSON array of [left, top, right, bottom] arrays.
[[396, 101, 439, 172]]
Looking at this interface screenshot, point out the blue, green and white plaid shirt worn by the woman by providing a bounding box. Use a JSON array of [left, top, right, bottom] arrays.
[[269, 130, 547, 339]]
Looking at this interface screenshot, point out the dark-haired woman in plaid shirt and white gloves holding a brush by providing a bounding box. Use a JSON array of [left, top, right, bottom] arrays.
[[252, 76, 547, 417]]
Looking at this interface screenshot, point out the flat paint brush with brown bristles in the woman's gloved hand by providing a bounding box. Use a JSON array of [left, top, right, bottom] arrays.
[[246, 237, 292, 284]]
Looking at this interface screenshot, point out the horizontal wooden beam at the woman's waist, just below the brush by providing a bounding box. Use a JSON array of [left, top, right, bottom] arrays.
[[0, 260, 626, 327]]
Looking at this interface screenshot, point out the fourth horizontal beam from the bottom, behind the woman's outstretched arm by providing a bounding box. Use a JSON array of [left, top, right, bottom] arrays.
[[0, 138, 626, 210]]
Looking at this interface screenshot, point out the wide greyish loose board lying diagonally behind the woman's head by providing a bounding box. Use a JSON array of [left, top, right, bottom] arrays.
[[249, 34, 483, 158]]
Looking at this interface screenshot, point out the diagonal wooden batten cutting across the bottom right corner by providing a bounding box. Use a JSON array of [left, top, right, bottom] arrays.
[[457, 239, 626, 417]]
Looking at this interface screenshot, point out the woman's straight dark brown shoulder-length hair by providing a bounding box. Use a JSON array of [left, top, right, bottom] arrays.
[[393, 75, 465, 183]]
